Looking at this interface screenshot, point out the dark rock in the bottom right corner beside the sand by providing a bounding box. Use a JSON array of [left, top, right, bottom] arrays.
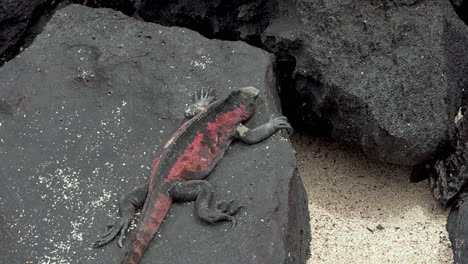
[[447, 195, 468, 264]]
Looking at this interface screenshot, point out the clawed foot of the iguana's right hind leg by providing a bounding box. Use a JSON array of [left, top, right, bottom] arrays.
[[198, 201, 242, 227]]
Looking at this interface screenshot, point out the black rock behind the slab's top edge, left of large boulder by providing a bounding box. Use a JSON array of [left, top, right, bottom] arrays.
[[133, 0, 278, 44]]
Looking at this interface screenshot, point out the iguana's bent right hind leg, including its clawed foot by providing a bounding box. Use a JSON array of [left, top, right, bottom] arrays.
[[169, 180, 240, 225]]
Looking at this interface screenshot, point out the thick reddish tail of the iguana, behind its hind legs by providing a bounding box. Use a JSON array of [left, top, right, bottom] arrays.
[[121, 193, 172, 264]]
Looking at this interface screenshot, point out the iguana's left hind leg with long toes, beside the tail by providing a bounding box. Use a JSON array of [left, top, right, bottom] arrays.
[[93, 183, 148, 247]]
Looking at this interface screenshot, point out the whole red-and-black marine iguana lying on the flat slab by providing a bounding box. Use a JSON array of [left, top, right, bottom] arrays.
[[94, 87, 292, 264]]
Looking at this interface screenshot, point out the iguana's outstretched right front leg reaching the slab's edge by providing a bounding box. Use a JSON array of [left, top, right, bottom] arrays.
[[236, 115, 293, 144]]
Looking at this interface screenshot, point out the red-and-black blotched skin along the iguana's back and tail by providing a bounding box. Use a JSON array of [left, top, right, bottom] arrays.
[[121, 98, 255, 264]]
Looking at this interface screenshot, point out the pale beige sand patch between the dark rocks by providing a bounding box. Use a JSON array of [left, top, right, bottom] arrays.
[[291, 132, 453, 264]]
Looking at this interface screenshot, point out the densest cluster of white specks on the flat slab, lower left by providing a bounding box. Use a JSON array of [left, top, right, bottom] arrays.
[[28, 164, 112, 264]]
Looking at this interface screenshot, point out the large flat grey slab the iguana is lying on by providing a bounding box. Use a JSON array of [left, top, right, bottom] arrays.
[[0, 5, 310, 264]]
